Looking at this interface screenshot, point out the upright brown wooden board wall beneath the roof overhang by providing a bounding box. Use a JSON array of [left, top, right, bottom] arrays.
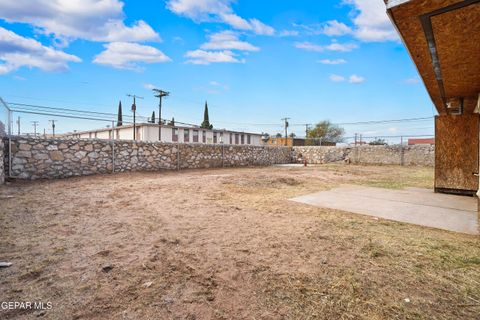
[[435, 114, 480, 195]]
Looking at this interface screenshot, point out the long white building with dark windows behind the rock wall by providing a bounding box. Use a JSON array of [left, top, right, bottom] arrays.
[[64, 123, 263, 146]]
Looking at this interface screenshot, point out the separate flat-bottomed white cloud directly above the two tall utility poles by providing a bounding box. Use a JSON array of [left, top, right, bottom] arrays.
[[93, 42, 171, 70]]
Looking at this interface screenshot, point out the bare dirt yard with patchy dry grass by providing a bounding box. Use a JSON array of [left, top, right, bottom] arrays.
[[0, 165, 480, 319]]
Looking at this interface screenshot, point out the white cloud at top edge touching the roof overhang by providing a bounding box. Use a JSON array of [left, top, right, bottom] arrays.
[[344, 0, 399, 42]]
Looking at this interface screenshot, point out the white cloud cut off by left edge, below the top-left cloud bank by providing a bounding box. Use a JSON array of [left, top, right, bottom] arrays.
[[0, 27, 82, 74]]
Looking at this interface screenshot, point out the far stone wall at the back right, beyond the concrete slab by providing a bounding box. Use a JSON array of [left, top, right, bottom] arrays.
[[292, 145, 435, 166]]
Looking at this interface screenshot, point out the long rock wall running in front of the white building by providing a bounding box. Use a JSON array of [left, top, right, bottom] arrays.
[[7, 137, 291, 180]]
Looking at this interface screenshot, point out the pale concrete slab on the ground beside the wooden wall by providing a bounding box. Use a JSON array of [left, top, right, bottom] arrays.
[[290, 186, 479, 235]]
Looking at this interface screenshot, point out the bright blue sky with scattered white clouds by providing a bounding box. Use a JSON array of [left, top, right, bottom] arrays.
[[0, 0, 434, 140]]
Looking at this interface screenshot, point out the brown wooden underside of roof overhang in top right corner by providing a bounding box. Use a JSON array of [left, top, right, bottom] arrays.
[[385, 0, 480, 114]]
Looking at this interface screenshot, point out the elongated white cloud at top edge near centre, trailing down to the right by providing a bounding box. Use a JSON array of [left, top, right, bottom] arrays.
[[167, 0, 275, 35]]
